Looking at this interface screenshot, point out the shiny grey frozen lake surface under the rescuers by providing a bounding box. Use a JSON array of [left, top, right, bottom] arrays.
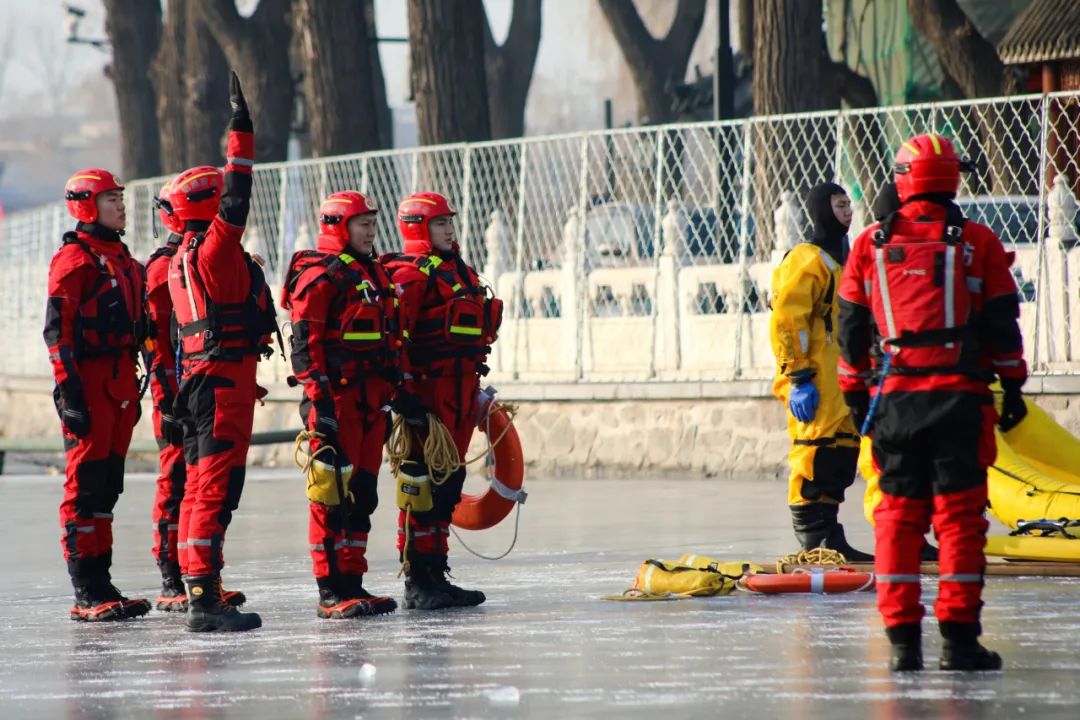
[[0, 463, 1080, 719]]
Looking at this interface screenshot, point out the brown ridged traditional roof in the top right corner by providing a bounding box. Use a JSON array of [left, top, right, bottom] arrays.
[[998, 0, 1080, 65]]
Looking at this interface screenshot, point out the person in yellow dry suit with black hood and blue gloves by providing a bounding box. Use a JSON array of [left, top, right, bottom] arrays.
[[769, 182, 874, 562]]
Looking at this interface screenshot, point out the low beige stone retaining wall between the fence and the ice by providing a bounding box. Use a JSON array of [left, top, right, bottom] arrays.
[[8, 378, 1080, 476]]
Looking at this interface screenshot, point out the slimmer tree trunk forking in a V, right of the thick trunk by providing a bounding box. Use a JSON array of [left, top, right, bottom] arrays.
[[484, 0, 542, 139]]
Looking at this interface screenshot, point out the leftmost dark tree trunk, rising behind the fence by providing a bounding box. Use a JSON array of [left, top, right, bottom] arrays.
[[105, 0, 161, 179]]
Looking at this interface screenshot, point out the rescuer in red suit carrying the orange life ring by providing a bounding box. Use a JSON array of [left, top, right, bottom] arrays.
[[383, 192, 502, 610]]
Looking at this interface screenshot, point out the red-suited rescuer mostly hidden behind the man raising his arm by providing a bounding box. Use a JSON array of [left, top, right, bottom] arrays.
[[146, 182, 244, 612]]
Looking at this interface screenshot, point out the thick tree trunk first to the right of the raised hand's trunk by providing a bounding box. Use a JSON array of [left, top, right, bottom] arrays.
[[293, 0, 382, 158]]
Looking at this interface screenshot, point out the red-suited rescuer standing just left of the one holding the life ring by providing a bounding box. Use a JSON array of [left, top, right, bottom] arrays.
[[282, 190, 402, 620]]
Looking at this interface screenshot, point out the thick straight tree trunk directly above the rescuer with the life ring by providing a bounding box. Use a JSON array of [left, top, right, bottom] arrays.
[[408, 0, 491, 145]]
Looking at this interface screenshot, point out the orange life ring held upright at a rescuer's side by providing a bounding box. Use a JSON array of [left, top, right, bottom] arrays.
[[450, 393, 526, 530]]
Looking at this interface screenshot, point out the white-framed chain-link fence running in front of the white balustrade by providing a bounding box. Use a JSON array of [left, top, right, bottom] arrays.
[[0, 93, 1080, 382]]
